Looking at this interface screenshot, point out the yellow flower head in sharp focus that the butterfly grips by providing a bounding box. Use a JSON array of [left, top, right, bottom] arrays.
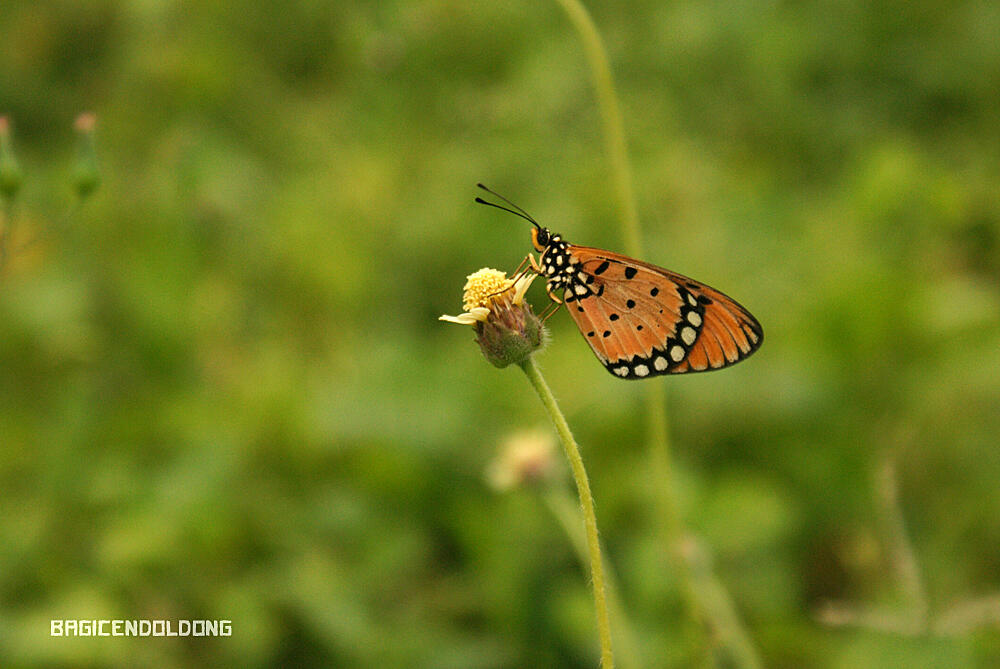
[[440, 268, 543, 367]]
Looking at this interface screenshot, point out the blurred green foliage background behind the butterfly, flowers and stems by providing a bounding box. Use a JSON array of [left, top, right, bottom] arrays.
[[0, 0, 1000, 669]]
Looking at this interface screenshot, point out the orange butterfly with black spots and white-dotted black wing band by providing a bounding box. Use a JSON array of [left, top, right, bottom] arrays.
[[476, 184, 764, 379]]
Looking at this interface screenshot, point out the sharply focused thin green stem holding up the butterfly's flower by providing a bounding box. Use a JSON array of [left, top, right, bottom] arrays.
[[520, 355, 615, 669]]
